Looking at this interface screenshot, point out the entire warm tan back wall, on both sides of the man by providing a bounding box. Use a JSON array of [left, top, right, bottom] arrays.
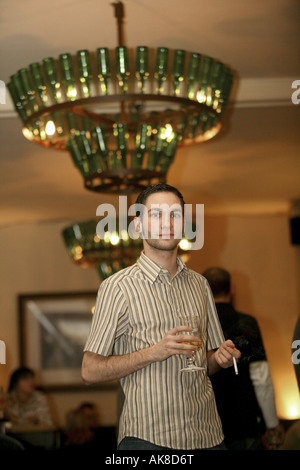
[[0, 214, 300, 425]]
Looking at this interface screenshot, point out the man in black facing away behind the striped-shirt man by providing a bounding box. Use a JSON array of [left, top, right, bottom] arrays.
[[203, 268, 281, 450]]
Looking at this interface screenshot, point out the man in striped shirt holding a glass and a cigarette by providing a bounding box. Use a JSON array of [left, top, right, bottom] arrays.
[[82, 184, 240, 450]]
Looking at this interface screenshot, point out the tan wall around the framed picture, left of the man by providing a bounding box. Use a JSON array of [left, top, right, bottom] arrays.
[[0, 222, 117, 425]]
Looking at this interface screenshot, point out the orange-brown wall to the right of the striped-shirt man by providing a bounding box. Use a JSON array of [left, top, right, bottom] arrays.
[[189, 214, 300, 419]]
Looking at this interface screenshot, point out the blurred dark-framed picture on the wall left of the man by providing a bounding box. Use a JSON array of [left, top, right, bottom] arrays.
[[19, 292, 97, 389]]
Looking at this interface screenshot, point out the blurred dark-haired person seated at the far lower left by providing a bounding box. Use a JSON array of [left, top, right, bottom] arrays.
[[4, 367, 54, 426]]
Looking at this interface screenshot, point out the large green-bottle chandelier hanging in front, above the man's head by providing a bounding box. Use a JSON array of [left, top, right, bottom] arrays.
[[7, 1, 233, 194]]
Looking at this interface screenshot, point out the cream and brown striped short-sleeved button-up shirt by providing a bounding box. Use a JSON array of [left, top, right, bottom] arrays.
[[85, 253, 224, 449]]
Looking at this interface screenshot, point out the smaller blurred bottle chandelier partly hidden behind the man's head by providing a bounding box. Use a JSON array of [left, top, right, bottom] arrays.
[[62, 219, 193, 279]]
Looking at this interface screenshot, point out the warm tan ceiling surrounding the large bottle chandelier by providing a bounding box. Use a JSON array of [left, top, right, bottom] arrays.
[[0, 0, 300, 226]]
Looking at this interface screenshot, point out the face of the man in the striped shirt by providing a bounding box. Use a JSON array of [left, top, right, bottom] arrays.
[[140, 192, 183, 251]]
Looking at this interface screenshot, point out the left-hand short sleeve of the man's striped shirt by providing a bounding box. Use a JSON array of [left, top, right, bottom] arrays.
[[84, 277, 128, 356]]
